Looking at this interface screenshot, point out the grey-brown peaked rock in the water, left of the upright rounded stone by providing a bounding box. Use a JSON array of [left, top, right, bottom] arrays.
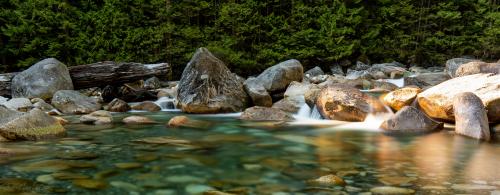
[[380, 106, 443, 133]]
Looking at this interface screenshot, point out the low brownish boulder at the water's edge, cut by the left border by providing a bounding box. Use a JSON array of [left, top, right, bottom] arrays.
[[0, 106, 66, 140]]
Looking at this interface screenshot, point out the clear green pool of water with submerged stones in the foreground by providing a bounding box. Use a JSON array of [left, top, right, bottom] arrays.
[[0, 113, 500, 194]]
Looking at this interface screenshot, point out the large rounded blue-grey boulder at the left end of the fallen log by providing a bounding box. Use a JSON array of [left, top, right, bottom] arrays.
[[12, 58, 73, 99]]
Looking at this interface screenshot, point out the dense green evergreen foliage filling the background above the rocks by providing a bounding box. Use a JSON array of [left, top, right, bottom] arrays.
[[0, 0, 500, 75]]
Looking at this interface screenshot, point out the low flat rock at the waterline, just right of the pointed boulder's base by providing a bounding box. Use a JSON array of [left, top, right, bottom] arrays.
[[240, 106, 294, 121]]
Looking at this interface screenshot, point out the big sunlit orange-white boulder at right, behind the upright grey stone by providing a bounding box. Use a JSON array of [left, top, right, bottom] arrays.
[[417, 74, 500, 122]]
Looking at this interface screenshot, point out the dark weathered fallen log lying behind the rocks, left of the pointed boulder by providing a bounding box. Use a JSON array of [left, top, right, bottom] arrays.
[[69, 61, 172, 89]]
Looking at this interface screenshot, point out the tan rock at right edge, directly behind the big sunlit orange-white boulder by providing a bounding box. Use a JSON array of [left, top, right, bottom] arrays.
[[455, 61, 500, 77]]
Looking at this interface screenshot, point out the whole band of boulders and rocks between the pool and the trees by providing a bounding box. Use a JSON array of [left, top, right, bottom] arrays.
[[0, 48, 500, 141]]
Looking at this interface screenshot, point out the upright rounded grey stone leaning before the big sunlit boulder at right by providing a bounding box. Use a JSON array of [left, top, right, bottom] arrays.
[[453, 92, 491, 140]]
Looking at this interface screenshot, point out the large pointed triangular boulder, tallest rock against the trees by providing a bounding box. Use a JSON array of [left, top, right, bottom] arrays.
[[177, 48, 249, 113]]
